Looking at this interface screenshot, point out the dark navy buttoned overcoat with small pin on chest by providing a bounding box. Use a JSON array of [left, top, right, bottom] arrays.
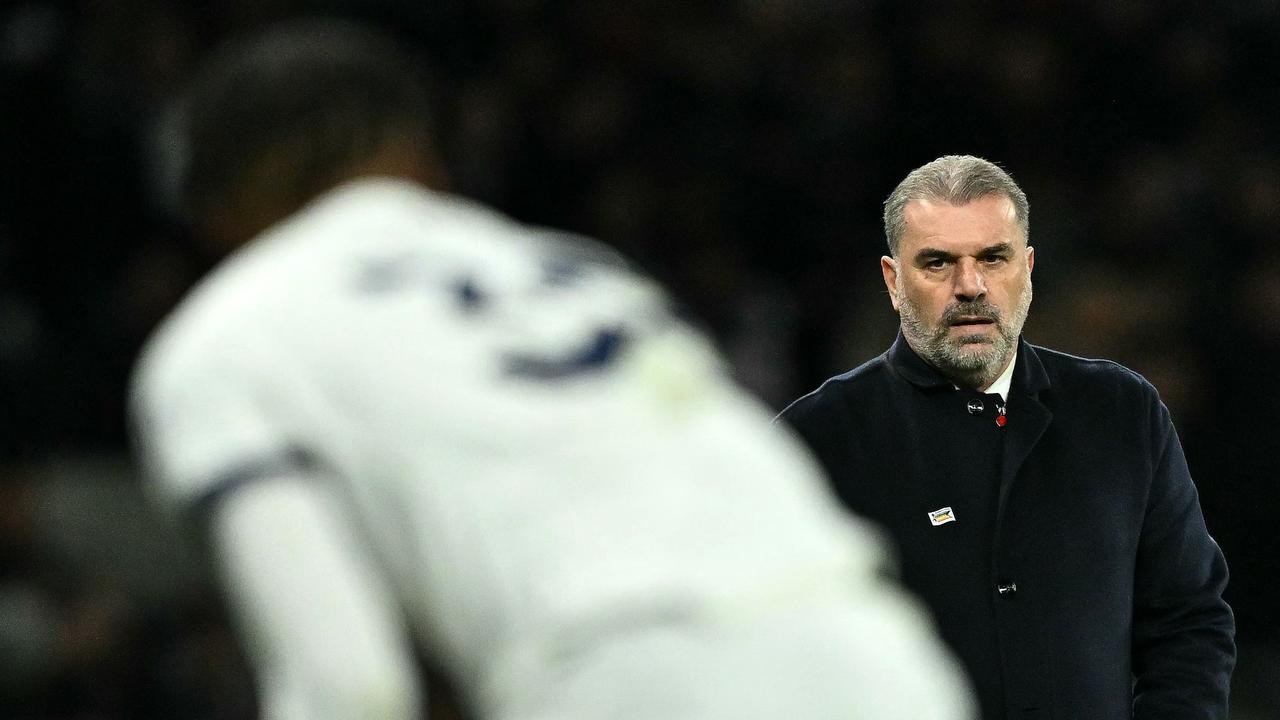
[[781, 334, 1235, 720]]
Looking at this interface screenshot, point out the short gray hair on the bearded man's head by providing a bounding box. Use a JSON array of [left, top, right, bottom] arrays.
[[884, 155, 1030, 258]]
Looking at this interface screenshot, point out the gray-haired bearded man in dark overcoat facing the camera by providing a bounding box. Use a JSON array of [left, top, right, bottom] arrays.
[[781, 155, 1235, 720]]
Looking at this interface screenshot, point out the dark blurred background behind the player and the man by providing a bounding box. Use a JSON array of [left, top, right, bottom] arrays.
[[0, 0, 1280, 719]]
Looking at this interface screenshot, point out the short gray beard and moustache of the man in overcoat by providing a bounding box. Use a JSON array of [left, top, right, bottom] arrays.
[[897, 279, 1032, 389]]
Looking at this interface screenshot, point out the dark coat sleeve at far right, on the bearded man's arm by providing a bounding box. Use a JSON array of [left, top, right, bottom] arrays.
[[1133, 398, 1235, 720]]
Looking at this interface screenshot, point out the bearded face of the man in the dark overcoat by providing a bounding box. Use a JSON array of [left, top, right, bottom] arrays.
[[881, 195, 1036, 389]]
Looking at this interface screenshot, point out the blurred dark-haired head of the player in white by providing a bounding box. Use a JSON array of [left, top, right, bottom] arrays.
[[157, 20, 444, 251]]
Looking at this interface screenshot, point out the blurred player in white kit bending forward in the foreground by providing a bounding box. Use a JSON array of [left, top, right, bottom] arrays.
[[132, 23, 972, 720]]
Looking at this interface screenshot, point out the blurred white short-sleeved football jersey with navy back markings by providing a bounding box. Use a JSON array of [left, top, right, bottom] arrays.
[[133, 179, 963, 717]]
